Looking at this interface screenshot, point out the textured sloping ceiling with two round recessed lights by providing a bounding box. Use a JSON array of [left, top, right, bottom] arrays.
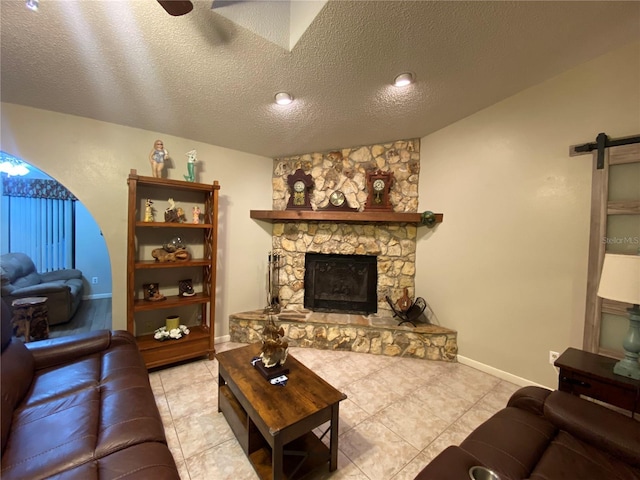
[[0, 0, 640, 157]]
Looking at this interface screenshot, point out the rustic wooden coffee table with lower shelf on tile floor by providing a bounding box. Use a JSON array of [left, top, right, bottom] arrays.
[[216, 343, 347, 480]]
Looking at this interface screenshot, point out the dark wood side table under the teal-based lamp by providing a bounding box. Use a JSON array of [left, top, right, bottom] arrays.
[[554, 348, 640, 415]]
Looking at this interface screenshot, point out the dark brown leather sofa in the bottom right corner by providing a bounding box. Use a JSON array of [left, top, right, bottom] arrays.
[[416, 387, 640, 480]]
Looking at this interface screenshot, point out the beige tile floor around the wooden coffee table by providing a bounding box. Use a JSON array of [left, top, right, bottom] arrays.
[[150, 343, 519, 480]]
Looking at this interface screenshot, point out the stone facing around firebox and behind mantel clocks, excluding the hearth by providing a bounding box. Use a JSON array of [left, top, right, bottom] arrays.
[[272, 139, 420, 315]]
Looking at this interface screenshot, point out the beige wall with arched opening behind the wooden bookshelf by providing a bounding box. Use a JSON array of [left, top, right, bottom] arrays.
[[1, 103, 272, 337]]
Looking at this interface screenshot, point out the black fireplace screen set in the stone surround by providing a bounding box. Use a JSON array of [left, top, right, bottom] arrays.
[[304, 253, 378, 314]]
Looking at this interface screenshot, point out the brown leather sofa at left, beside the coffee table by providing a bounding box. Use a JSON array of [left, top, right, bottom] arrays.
[[0, 301, 180, 480]]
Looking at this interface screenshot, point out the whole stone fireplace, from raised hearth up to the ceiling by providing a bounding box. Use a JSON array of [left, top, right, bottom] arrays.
[[229, 135, 457, 361]]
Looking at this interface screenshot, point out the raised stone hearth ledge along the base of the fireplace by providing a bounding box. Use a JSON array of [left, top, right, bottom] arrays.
[[229, 309, 458, 362]]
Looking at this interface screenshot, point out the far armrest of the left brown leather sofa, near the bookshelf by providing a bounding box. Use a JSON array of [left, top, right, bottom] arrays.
[[25, 330, 111, 370]]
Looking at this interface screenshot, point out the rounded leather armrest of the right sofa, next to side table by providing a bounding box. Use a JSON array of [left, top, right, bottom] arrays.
[[544, 391, 640, 467]]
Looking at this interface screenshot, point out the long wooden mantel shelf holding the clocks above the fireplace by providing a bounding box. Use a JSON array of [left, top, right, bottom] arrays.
[[250, 210, 444, 224]]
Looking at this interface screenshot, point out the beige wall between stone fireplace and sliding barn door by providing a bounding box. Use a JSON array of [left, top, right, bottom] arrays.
[[416, 44, 640, 387]]
